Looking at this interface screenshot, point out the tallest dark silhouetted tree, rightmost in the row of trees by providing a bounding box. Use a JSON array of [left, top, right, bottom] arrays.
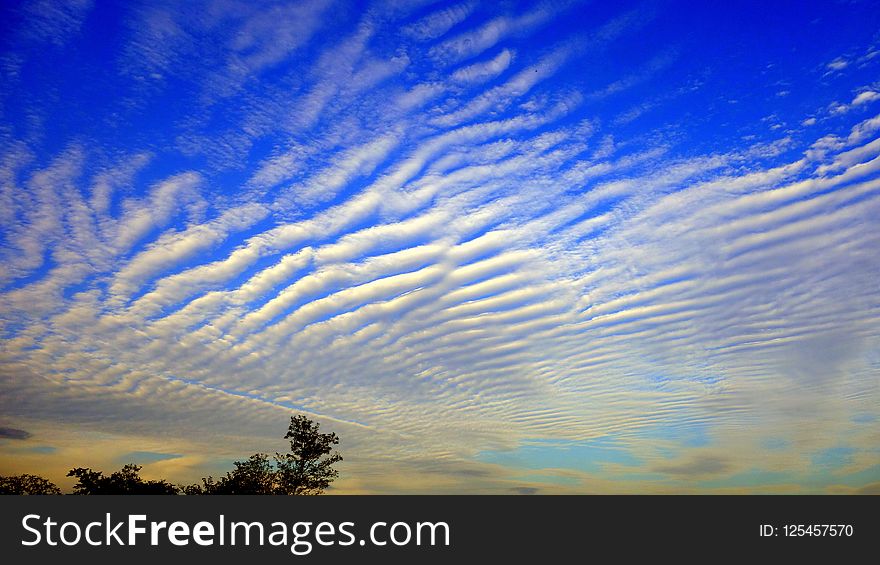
[[275, 414, 342, 494]]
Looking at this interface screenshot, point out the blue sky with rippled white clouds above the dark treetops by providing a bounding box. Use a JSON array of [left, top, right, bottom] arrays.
[[0, 0, 880, 494]]
